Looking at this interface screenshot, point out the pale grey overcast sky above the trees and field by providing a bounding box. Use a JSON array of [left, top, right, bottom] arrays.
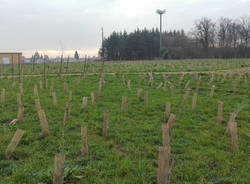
[[0, 0, 250, 56]]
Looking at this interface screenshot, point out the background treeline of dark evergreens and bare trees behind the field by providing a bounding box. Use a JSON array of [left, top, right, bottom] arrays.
[[99, 16, 250, 60]]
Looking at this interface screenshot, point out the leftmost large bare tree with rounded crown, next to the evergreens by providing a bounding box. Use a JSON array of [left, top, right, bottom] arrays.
[[193, 17, 216, 50]]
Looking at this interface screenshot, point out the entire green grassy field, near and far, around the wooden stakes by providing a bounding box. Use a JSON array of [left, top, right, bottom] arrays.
[[0, 60, 250, 184]]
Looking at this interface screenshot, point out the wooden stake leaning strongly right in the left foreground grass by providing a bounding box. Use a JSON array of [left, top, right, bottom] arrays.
[[5, 129, 24, 159]]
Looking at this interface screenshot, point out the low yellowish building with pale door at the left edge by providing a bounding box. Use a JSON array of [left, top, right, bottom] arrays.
[[0, 52, 23, 64]]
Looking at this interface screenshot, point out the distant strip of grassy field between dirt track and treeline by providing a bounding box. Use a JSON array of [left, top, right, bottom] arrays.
[[0, 59, 250, 75]]
